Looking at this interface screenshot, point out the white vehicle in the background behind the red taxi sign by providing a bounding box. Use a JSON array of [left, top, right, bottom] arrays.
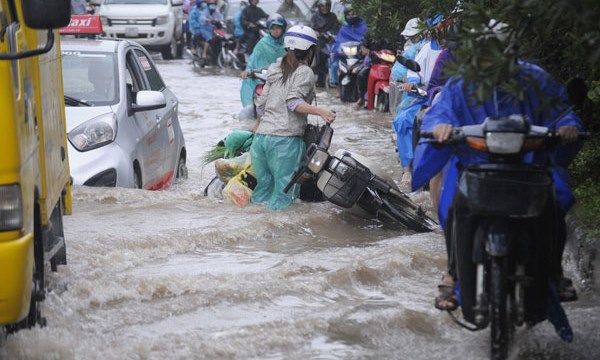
[[92, 0, 184, 60]]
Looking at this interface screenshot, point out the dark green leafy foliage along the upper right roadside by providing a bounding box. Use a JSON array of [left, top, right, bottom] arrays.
[[352, 0, 600, 238]]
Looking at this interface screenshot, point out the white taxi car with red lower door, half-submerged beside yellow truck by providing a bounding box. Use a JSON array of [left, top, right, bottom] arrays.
[[61, 39, 187, 190]]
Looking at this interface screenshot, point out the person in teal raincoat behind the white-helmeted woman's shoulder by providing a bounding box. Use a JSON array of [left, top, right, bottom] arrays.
[[239, 14, 287, 120]]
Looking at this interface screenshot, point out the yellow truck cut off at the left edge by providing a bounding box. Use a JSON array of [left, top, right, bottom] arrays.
[[0, 0, 71, 332]]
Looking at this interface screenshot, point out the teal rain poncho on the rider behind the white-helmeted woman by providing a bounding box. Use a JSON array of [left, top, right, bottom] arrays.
[[240, 34, 285, 107]]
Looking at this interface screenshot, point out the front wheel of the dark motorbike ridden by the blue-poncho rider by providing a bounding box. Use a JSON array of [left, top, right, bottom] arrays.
[[490, 258, 510, 360]]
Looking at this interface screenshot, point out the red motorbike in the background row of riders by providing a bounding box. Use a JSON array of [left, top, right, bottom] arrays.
[[367, 49, 396, 112]]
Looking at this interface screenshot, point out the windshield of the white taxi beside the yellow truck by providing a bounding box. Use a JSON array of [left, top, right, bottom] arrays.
[[62, 50, 119, 106]]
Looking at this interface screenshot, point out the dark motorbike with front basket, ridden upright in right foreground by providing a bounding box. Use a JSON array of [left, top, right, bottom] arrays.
[[420, 114, 584, 359]]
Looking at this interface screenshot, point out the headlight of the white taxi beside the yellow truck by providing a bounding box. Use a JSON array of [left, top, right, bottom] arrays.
[[68, 113, 117, 151]]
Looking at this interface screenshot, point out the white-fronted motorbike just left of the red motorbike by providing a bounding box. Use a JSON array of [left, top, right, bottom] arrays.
[[337, 41, 363, 102]]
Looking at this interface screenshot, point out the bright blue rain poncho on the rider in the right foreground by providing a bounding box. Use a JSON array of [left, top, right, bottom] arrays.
[[412, 62, 583, 226]]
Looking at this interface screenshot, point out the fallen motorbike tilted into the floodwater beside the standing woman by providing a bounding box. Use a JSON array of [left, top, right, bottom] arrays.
[[284, 124, 438, 232]]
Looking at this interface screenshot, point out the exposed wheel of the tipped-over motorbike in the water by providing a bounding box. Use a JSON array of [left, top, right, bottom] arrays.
[[379, 190, 437, 232]]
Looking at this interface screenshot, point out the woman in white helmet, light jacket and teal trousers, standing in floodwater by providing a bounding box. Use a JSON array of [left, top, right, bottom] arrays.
[[250, 25, 335, 210]]
